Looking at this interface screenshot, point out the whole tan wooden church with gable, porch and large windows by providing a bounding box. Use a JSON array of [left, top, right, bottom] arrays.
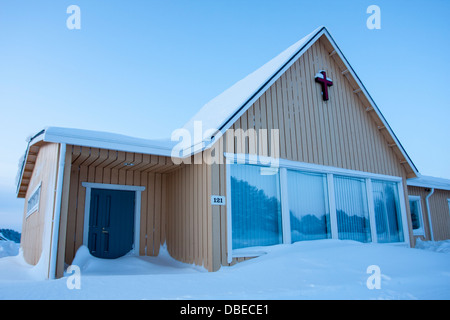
[[18, 28, 450, 278]]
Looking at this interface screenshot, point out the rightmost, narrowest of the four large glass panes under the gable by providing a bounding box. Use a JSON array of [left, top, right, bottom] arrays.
[[372, 180, 403, 242]]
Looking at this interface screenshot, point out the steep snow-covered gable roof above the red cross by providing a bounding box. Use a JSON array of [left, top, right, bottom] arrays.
[[178, 26, 419, 180]]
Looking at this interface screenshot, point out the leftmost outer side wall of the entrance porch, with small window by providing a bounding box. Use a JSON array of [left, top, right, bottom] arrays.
[[20, 143, 59, 265]]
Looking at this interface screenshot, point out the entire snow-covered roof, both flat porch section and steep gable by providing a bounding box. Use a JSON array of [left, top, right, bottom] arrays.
[[19, 27, 419, 198]]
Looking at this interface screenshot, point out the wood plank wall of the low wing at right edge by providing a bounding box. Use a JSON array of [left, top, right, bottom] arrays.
[[408, 186, 450, 241]]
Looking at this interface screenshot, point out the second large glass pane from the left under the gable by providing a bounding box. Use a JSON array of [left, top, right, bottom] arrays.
[[287, 170, 331, 242]]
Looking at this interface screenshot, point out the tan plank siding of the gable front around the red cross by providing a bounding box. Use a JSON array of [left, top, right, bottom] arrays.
[[212, 39, 411, 265]]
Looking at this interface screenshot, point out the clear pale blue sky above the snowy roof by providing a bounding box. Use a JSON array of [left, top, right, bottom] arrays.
[[0, 0, 450, 229]]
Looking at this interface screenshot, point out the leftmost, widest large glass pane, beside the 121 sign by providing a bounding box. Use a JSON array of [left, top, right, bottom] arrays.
[[231, 165, 282, 249]]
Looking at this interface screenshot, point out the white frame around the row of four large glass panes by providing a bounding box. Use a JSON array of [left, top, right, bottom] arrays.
[[224, 153, 410, 263]]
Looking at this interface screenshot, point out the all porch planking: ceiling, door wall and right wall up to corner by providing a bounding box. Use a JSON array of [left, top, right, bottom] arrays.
[[65, 146, 220, 271]]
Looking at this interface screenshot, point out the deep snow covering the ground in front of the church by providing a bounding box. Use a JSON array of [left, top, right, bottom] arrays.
[[0, 240, 450, 300]]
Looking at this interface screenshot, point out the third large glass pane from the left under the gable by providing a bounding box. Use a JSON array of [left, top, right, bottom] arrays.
[[334, 176, 371, 242]]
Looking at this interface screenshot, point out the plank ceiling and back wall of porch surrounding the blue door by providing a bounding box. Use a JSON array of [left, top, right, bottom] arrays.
[[65, 146, 179, 264]]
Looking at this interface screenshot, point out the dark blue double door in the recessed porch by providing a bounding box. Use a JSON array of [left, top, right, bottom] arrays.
[[88, 189, 135, 259]]
